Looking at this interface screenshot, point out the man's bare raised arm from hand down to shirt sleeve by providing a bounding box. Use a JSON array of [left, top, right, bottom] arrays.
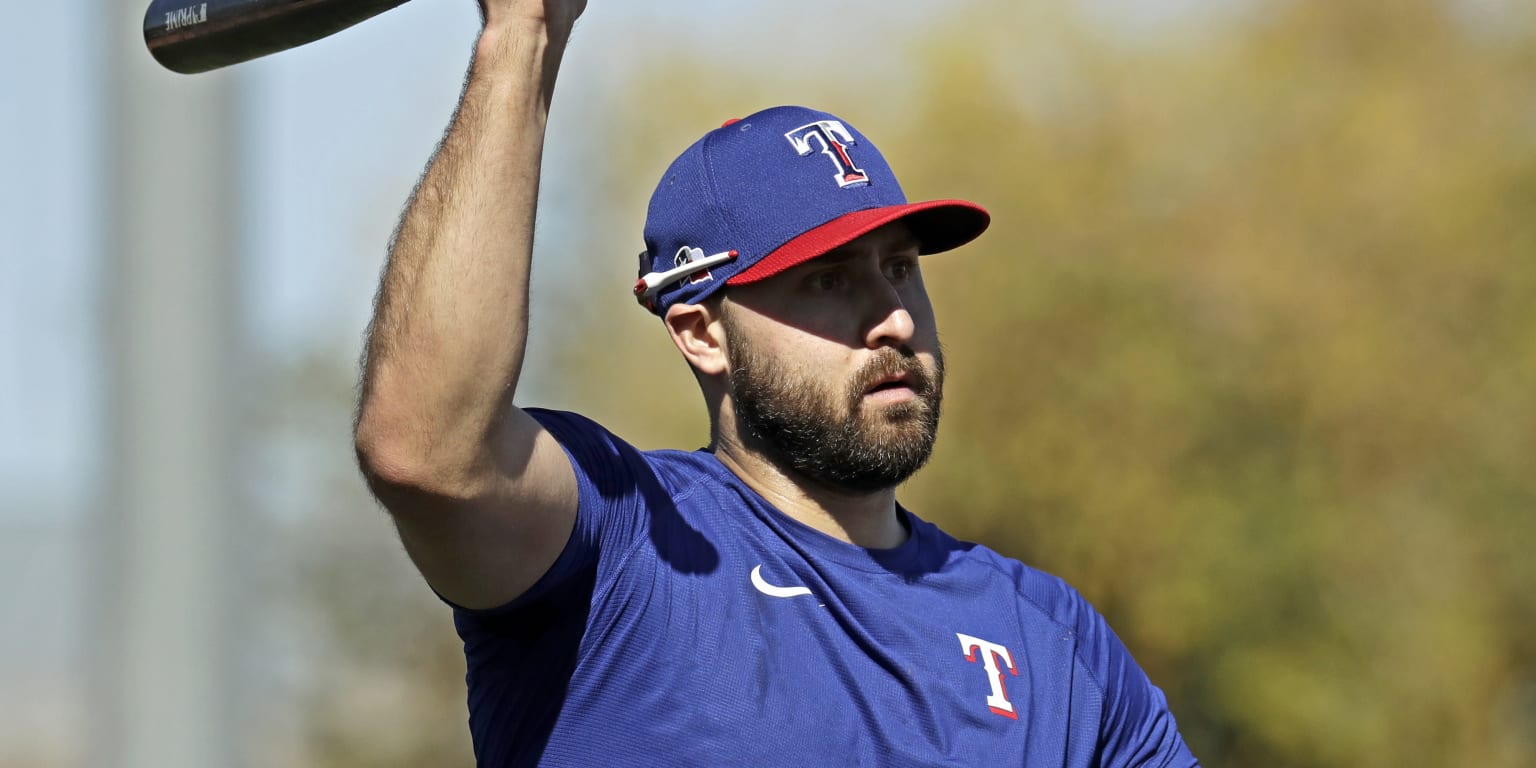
[[355, 0, 587, 608]]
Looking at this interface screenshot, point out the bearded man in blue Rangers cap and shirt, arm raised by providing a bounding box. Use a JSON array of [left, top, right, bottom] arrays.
[[356, 0, 1193, 766]]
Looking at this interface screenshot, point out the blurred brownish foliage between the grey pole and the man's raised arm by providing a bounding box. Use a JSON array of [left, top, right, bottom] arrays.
[[258, 350, 475, 768]]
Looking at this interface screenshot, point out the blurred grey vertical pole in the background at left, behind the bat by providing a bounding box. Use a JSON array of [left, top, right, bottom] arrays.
[[86, 0, 241, 768]]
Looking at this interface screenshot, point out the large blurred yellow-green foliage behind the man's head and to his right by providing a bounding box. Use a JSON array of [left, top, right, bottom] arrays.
[[549, 0, 1536, 766]]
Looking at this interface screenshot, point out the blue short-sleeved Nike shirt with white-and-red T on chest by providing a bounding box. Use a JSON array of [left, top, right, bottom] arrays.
[[455, 410, 1197, 768]]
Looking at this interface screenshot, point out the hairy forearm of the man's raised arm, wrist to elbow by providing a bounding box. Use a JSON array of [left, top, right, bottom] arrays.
[[358, 22, 565, 473]]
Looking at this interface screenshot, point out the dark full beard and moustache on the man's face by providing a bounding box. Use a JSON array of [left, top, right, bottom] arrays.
[[727, 321, 945, 493]]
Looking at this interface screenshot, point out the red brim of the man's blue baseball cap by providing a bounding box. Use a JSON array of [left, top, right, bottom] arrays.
[[725, 200, 992, 286]]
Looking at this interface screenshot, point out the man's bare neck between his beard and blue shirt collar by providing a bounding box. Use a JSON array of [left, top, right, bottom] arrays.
[[714, 439, 908, 550]]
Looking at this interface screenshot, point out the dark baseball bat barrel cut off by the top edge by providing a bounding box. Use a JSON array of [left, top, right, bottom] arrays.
[[144, 0, 409, 74]]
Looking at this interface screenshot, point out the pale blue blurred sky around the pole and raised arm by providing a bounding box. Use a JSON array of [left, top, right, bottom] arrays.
[[0, 0, 1247, 755]]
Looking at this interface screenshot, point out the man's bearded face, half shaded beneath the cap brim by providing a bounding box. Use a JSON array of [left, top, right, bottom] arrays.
[[722, 224, 943, 492]]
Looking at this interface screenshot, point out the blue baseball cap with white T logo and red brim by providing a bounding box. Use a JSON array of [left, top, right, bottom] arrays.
[[634, 106, 991, 315]]
